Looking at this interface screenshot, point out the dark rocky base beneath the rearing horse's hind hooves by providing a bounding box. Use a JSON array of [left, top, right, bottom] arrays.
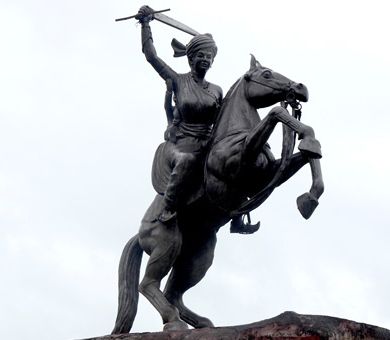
[[77, 312, 390, 340]]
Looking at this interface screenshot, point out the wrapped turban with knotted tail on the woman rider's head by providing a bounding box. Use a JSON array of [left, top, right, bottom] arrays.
[[171, 33, 217, 58]]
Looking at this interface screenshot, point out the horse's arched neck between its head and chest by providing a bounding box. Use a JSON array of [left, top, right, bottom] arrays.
[[213, 80, 260, 140]]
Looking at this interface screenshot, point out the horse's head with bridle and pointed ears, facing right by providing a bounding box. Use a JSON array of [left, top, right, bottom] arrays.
[[244, 55, 309, 109]]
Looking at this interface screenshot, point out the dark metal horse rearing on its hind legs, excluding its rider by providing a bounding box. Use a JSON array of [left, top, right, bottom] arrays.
[[112, 56, 324, 334]]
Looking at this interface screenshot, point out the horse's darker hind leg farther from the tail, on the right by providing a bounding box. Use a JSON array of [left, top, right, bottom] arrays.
[[164, 233, 217, 328]]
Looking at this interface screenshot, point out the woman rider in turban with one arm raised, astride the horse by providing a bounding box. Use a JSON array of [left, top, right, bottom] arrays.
[[137, 6, 222, 223]]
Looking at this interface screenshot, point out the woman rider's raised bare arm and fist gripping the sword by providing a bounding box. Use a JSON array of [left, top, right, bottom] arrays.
[[136, 6, 177, 82]]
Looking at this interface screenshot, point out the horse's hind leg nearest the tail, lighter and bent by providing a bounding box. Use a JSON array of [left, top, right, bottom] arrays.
[[139, 197, 188, 330]]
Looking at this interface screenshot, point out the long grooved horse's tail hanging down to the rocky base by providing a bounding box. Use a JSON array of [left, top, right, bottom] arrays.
[[112, 234, 143, 334]]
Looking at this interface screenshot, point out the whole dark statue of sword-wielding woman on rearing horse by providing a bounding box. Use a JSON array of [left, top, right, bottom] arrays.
[[112, 6, 324, 334]]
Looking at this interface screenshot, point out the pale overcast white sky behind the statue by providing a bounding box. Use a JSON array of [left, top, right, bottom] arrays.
[[0, 0, 390, 340]]
